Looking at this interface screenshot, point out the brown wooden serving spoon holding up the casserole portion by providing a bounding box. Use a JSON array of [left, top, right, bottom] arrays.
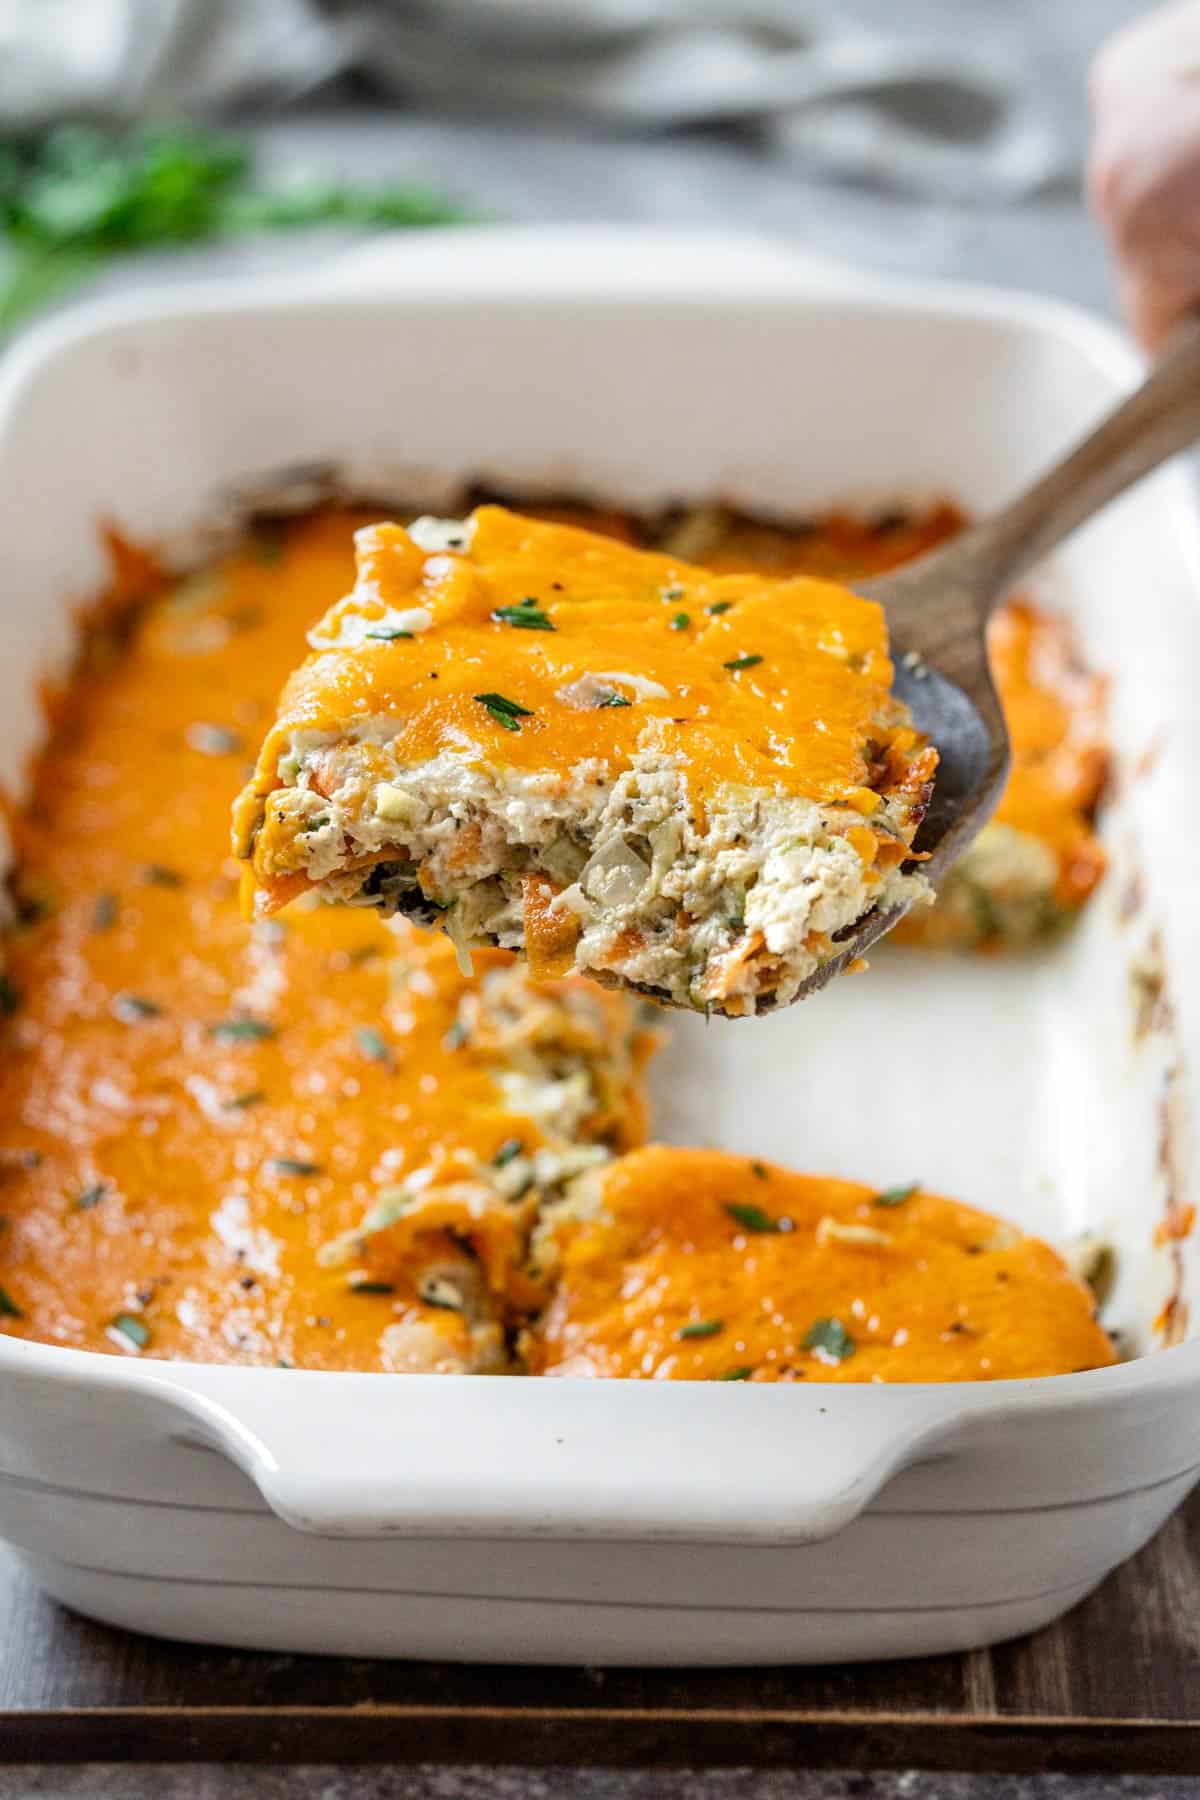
[[802, 320, 1200, 994]]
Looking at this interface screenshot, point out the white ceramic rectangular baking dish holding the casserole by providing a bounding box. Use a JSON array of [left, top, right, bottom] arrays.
[[0, 232, 1200, 1663]]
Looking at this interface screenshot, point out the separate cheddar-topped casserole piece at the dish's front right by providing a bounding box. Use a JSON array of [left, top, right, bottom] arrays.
[[525, 1147, 1115, 1381]]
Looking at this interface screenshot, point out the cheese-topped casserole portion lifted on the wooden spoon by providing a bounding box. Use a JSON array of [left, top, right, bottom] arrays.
[[234, 506, 937, 1015]]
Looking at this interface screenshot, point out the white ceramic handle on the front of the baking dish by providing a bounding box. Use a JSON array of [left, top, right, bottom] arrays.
[[152, 1368, 963, 1543]]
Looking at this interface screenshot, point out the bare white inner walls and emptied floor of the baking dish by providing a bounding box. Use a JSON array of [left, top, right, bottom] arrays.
[[0, 277, 1200, 1350]]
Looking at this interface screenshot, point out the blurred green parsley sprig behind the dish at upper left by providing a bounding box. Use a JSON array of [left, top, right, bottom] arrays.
[[0, 124, 473, 338]]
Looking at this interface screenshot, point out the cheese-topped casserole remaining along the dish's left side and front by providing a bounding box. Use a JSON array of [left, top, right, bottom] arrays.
[[0, 511, 1110, 1381]]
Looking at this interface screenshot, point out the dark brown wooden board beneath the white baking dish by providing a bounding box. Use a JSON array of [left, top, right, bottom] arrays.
[[0, 1490, 1200, 1775]]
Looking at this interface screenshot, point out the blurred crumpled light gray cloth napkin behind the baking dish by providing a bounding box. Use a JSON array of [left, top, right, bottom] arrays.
[[0, 0, 1072, 200]]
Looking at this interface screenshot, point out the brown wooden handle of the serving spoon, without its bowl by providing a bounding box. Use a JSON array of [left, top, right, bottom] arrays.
[[871, 319, 1200, 650]]
